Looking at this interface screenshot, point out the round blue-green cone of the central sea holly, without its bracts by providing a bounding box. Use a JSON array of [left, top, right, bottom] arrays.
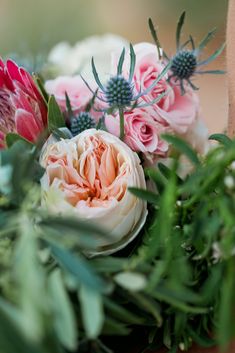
[[104, 75, 133, 107]]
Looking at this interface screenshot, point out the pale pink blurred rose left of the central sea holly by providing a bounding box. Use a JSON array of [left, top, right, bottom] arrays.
[[45, 76, 92, 113]]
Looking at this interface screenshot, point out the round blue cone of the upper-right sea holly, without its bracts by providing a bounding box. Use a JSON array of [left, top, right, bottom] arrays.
[[170, 50, 197, 80]]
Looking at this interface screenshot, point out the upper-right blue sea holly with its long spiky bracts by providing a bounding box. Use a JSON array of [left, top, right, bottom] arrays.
[[149, 11, 225, 95]]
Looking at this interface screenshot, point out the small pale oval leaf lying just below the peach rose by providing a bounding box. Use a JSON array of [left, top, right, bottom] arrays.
[[114, 271, 147, 292]]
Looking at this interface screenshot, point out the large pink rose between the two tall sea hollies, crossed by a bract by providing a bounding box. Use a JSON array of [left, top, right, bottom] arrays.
[[129, 43, 199, 134]]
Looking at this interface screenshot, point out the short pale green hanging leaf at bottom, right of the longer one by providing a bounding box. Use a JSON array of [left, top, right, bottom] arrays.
[[79, 285, 104, 339]]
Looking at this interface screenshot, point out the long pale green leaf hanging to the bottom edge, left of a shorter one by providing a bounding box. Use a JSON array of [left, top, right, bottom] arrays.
[[48, 269, 78, 350]]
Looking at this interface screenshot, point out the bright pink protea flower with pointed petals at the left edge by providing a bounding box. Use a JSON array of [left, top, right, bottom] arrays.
[[0, 59, 47, 148]]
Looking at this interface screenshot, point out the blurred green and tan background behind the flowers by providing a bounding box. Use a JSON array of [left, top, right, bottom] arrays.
[[0, 0, 228, 132]]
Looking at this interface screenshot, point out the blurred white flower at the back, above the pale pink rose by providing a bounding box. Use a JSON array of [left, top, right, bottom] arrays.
[[48, 34, 128, 80]]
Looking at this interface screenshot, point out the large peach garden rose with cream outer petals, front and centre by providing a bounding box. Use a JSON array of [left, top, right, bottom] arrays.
[[41, 129, 146, 253]]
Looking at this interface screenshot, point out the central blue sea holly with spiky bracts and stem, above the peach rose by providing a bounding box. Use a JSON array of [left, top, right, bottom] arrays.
[[82, 44, 171, 139]]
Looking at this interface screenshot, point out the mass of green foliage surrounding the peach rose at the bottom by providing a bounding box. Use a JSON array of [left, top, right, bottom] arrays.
[[0, 133, 235, 353]]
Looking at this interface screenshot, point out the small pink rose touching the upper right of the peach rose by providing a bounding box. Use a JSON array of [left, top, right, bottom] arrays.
[[105, 107, 168, 157]]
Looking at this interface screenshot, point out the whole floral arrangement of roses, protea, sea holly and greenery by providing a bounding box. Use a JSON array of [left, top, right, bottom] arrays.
[[0, 13, 235, 353]]
